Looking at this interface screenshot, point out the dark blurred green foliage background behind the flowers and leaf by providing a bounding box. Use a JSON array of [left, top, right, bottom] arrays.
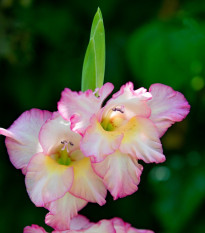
[[0, 0, 205, 233]]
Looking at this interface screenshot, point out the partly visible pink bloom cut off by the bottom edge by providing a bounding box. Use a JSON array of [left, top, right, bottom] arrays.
[[23, 215, 154, 233]]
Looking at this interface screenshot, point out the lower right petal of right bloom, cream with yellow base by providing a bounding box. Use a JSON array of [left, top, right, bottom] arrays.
[[119, 117, 165, 163]]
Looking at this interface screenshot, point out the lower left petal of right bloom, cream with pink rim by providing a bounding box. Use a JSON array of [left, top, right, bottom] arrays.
[[80, 116, 123, 162]]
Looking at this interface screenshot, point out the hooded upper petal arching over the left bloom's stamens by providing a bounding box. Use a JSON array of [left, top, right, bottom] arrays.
[[39, 113, 81, 155]]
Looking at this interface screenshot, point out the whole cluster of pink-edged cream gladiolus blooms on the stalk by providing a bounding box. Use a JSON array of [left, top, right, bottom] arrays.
[[0, 82, 190, 233]]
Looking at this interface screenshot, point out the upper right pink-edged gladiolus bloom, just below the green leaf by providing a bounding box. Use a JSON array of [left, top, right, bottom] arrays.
[[58, 82, 190, 199]]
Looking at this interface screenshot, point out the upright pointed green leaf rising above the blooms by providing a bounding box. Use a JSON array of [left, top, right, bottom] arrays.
[[81, 8, 105, 91]]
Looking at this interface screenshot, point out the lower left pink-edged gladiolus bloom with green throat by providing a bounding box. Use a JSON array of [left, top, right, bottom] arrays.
[[0, 109, 106, 230]]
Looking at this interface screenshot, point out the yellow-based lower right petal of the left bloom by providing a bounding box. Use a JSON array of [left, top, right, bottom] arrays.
[[70, 158, 107, 205]]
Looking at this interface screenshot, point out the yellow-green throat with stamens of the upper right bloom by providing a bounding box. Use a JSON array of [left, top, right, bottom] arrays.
[[101, 106, 126, 131]]
